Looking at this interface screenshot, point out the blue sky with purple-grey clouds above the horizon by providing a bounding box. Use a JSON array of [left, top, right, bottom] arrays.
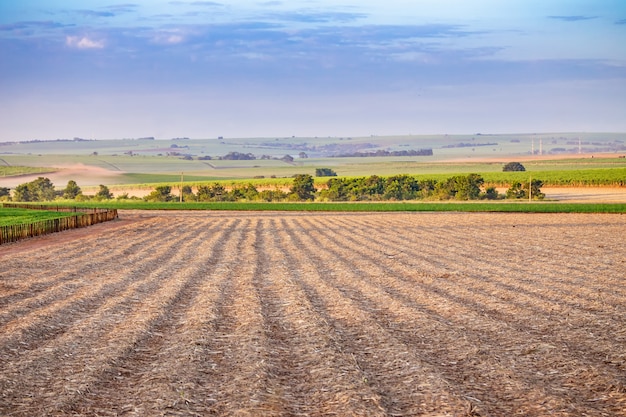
[[0, 0, 626, 141]]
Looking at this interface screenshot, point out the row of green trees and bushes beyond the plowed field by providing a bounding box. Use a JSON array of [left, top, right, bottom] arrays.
[[0, 174, 544, 202]]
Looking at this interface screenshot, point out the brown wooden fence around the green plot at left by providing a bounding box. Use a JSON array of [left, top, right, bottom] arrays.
[[0, 203, 118, 245]]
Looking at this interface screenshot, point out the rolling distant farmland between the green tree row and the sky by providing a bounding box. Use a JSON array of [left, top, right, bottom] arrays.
[[0, 133, 626, 188]]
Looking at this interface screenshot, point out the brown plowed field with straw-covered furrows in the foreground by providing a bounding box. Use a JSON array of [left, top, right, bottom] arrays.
[[0, 212, 626, 416]]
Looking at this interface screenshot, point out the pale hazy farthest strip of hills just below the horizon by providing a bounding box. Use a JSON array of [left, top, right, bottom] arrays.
[[0, 132, 626, 160]]
